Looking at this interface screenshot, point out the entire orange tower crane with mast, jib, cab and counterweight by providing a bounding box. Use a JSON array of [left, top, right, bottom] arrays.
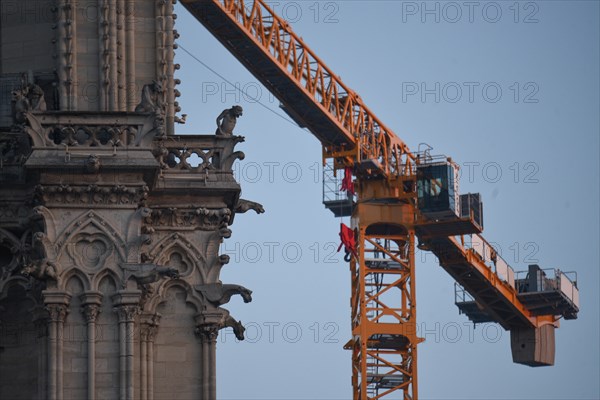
[[182, 0, 579, 400]]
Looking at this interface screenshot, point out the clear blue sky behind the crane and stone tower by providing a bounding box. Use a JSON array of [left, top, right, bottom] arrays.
[[171, 0, 600, 399]]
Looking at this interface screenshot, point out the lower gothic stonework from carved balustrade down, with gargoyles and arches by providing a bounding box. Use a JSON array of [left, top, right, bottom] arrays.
[[0, 111, 255, 400]]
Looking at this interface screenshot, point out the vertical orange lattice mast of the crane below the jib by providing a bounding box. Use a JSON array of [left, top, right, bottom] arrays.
[[346, 202, 422, 400]]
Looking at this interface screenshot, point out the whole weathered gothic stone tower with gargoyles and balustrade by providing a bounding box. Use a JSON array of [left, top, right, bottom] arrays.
[[0, 0, 263, 400]]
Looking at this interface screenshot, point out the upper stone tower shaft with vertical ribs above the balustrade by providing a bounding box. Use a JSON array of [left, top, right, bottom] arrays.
[[0, 0, 177, 123]]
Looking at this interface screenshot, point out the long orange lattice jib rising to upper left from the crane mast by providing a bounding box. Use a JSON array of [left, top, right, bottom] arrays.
[[182, 0, 415, 177]]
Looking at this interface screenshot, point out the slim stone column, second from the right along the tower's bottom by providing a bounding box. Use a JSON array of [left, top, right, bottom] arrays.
[[140, 313, 161, 400]]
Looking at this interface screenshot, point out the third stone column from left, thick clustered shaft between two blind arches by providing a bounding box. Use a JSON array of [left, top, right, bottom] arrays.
[[113, 290, 141, 400]]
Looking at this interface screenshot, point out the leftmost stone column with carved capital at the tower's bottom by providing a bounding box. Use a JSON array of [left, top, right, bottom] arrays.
[[42, 290, 71, 400]]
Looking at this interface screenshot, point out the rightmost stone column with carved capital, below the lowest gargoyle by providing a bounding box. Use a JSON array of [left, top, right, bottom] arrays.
[[196, 323, 220, 400]]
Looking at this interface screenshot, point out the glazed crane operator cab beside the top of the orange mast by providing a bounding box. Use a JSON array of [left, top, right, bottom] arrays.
[[417, 156, 483, 237]]
